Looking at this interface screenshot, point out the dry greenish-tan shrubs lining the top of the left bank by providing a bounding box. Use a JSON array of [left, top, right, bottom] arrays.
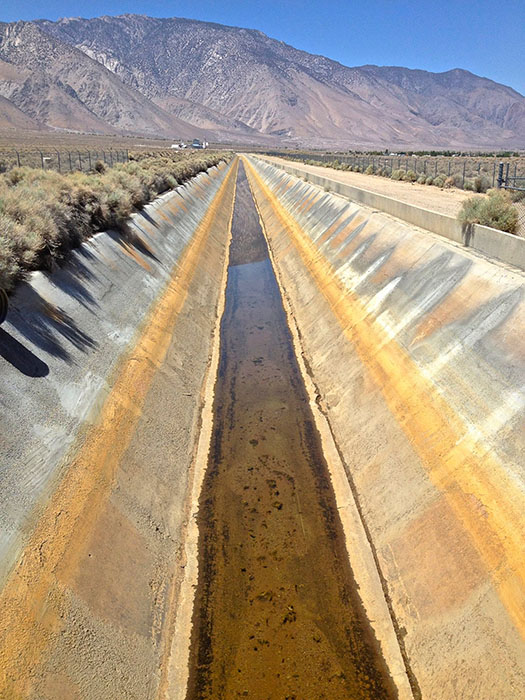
[[0, 151, 231, 291]]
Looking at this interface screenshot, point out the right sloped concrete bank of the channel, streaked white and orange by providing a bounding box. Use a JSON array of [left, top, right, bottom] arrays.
[[248, 158, 525, 700]]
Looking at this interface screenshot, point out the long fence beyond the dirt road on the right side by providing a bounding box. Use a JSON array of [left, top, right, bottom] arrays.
[[266, 151, 525, 190]]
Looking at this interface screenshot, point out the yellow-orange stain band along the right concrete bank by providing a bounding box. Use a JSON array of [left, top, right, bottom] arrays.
[[244, 160, 525, 639]]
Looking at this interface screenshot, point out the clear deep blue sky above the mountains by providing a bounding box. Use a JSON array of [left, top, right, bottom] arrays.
[[4, 0, 525, 94]]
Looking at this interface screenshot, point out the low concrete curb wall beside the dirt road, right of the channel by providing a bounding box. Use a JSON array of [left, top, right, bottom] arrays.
[[260, 160, 525, 270]]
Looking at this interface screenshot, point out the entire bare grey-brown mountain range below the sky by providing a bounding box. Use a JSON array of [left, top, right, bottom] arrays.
[[0, 15, 525, 148]]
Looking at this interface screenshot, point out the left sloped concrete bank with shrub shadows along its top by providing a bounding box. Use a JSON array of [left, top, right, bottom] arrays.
[[0, 164, 236, 700]]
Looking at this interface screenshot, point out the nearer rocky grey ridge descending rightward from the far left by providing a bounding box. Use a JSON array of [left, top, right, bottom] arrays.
[[0, 22, 211, 138]]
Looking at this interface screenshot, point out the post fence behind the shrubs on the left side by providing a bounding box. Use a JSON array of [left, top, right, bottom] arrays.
[[0, 148, 129, 173]]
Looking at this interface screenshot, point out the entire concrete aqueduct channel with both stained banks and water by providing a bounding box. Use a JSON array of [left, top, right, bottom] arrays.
[[0, 156, 525, 700]]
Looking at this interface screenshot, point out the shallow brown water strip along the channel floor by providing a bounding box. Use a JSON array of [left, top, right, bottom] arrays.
[[184, 167, 395, 700]]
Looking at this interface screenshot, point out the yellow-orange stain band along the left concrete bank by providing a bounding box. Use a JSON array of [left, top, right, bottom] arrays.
[[0, 159, 237, 700]]
